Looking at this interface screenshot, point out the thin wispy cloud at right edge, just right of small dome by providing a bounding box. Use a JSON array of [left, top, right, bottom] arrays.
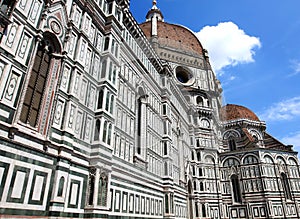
[[260, 97, 300, 121]]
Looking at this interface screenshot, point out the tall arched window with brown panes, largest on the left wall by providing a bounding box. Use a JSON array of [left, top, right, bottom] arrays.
[[20, 41, 53, 127]]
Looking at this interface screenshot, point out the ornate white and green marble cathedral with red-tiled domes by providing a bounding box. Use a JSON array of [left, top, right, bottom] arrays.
[[0, 0, 300, 219]]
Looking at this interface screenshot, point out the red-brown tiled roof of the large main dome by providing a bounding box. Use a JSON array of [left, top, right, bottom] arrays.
[[140, 21, 203, 56]]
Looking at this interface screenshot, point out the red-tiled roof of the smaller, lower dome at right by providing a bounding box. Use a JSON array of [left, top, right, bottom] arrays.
[[220, 104, 260, 122]]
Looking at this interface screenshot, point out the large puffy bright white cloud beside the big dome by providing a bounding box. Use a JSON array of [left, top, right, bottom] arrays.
[[196, 22, 261, 74]]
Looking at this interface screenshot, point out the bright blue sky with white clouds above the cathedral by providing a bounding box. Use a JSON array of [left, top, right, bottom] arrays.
[[130, 0, 300, 151]]
